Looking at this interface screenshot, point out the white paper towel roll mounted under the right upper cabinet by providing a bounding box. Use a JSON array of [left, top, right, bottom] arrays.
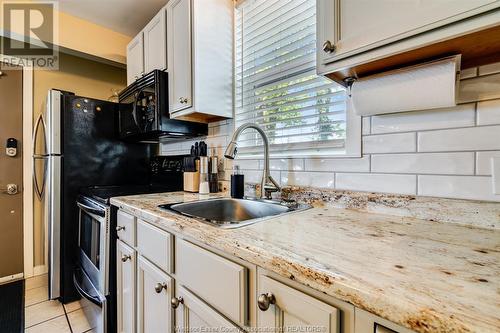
[[351, 55, 460, 116]]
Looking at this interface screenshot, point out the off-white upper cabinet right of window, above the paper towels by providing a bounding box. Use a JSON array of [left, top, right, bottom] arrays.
[[317, 0, 500, 82]]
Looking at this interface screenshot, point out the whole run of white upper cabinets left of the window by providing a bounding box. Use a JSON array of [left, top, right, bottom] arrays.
[[127, 0, 234, 122]]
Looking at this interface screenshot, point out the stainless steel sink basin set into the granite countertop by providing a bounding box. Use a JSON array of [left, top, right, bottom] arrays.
[[159, 198, 311, 228]]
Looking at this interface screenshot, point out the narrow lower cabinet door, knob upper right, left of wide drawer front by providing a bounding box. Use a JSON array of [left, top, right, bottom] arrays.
[[137, 256, 173, 333]]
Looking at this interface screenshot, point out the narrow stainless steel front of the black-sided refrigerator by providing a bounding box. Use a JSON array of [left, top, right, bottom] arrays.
[[44, 90, 62, 299]]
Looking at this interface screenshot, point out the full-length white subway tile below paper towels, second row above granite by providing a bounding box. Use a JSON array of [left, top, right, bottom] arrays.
[[371, 152, 474, 175]]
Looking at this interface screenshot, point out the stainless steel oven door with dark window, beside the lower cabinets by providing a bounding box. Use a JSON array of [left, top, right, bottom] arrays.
[[77, 197, 109, 296]]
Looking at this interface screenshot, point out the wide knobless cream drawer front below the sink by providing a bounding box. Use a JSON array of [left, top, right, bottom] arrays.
[[175, 239, 248, 325]]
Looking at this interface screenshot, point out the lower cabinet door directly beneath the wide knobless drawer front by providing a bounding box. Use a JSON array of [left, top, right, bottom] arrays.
[[175, 286, 243, 333]]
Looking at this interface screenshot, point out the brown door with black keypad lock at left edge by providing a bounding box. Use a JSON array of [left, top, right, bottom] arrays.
[[0, 68, 23, 279]]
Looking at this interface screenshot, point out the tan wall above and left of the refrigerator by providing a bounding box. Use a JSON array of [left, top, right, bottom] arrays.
[[33, 54, 126, 266]]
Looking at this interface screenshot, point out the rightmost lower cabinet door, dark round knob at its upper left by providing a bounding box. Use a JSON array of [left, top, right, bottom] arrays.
[[257, 275, 340, 333]]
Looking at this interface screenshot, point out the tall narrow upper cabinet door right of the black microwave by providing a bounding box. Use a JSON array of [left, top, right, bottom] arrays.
[[167, 0, 193, 112]]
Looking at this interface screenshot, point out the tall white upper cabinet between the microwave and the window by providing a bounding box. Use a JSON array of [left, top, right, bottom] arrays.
[[167, 0, 234, 121]]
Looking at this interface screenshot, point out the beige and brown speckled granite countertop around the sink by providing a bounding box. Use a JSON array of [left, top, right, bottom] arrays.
[[111, 192, 500, 333]]
